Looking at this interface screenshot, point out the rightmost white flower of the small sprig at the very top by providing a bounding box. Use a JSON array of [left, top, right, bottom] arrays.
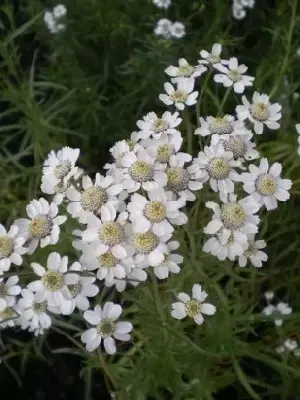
[[214, 57, 254, 93]]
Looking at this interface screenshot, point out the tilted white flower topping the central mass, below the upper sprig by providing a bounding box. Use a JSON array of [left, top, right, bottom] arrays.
[[136, 111, 182, 139]]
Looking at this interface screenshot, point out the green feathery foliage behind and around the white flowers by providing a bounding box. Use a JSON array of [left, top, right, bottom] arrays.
[[0, 0, 300, 400]]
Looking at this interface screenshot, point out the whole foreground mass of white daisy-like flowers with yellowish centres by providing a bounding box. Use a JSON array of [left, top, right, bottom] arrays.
[[0, 44, 291, 354]]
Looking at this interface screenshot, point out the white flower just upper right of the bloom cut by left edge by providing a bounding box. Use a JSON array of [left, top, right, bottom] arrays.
[[15, 198, 67, 254]]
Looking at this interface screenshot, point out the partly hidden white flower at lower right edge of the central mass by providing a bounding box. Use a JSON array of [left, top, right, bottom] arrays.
[[154, 240, 183, 279]]
